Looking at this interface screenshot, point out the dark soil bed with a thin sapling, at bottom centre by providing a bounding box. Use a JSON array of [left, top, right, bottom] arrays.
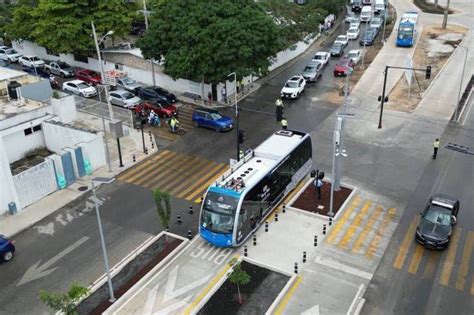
[[198, 260, 290, 315]]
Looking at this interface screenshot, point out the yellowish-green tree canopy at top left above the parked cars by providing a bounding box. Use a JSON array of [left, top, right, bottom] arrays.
[[6, 0, 137, 53]]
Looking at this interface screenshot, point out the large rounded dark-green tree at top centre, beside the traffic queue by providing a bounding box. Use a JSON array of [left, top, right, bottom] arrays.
[[137, 0, 282, 83]]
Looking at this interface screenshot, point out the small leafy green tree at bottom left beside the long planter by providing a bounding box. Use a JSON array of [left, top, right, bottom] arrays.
[[38, 282, 89, 315]]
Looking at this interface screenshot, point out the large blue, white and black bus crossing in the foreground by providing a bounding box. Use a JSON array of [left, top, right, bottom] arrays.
[[199, 130, 313, 247]]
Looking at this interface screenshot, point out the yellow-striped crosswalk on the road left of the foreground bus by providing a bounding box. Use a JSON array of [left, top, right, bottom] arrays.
[[117, 150, 229, 203]]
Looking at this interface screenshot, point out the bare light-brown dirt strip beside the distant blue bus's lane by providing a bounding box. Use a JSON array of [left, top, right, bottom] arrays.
[[386, 25, 467, 113]]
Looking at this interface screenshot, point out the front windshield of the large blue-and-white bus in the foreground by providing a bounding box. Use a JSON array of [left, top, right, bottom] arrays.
[[201, 191, 239, 233]]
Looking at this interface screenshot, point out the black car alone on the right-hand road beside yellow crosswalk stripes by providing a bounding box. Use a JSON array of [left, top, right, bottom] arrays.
[[415, 194, 459, 249]]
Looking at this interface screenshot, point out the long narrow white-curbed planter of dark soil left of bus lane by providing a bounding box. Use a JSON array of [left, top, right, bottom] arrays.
[[77, 232, 188, 314]]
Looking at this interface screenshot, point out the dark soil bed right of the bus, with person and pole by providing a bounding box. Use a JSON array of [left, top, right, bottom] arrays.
[[291, 181, 352, 215]]
